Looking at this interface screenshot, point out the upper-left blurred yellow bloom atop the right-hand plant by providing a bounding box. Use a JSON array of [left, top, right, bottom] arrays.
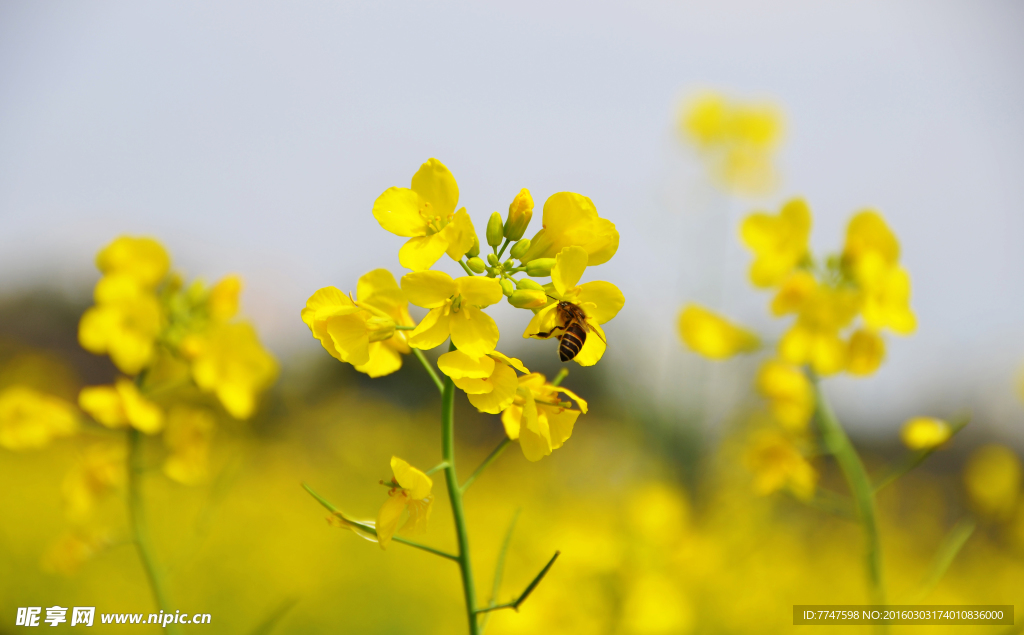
[[740, 199, 811, 287]]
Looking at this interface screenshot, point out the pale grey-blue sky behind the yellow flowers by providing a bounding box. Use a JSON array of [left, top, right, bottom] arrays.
[[0, 0, 1024, 434]]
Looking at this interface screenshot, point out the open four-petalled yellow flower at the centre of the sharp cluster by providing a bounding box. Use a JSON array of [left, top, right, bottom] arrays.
[[401, 271, 504, 358]]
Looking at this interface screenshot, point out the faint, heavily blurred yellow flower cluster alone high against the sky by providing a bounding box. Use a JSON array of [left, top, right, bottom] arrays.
[[679, 92, 783, 196]]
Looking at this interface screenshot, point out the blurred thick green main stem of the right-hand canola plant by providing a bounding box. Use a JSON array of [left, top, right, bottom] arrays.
[[811, 376, 886, 604]]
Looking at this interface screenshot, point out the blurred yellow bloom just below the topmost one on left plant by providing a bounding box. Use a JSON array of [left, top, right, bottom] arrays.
[[78, 284, 164, 375]]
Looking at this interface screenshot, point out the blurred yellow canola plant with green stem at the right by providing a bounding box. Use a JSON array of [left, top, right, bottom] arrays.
[[678, 197, 966, 603]]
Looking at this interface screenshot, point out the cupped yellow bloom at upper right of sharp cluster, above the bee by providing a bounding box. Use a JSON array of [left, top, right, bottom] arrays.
[[519, 192, 618, 266]]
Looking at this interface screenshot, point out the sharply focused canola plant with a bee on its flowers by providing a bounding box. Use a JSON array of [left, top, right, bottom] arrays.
[[301, 159, 625, 634]]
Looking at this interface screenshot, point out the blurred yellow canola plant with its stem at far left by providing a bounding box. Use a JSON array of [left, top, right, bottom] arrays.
[[6, 236, 278, 626]]
